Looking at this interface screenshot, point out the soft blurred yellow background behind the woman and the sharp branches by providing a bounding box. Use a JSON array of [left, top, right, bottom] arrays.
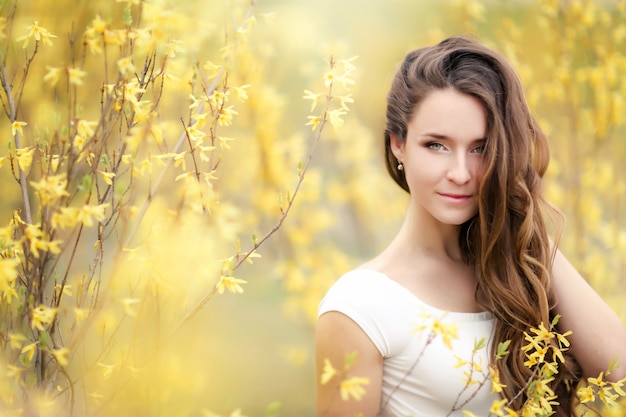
[[0, 0, 626, 416]]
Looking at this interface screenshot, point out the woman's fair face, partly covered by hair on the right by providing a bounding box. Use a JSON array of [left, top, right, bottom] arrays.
[[391, 89, 487, 225]]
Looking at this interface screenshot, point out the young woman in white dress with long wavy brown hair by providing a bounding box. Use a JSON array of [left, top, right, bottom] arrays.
[[316, 37, 626, 417]]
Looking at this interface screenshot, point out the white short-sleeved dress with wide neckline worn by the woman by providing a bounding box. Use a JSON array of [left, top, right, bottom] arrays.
[[318, 269, 499, 417]]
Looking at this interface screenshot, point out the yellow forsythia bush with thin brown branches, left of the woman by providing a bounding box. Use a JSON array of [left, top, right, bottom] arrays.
[[0, 0, 354, 416]]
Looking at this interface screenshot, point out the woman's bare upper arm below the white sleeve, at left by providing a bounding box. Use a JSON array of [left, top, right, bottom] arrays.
[[315, 311, 383, 417]]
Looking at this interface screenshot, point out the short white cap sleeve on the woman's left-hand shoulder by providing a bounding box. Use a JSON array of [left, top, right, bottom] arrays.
[[318, 270, 411, 358]]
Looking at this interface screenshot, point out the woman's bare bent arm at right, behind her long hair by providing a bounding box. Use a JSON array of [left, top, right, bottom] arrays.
[[552, 247, 626, 381]]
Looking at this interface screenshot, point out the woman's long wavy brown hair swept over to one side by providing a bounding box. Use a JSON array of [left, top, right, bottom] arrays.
[[385, 36, 581, 416]]
